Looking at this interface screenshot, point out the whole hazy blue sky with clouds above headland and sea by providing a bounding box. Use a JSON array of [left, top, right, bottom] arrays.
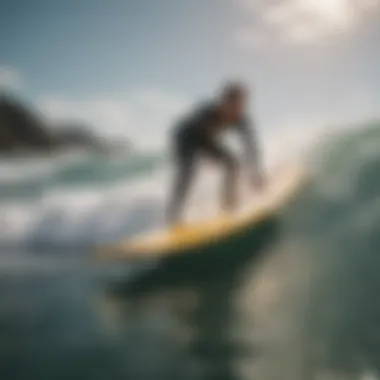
[[0, 0, 380, 145]]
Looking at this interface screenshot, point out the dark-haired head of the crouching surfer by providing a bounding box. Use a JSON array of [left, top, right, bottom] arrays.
[[220, 82, 248, 120]]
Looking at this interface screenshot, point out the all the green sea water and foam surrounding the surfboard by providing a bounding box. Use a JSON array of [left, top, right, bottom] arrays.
[[0, 124, 380, 380]]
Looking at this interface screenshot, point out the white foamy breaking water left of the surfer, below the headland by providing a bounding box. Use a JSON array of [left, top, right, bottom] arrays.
[[0, 153, 171, 250]]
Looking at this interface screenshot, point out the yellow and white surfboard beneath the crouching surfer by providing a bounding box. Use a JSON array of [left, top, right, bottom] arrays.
[[97, 165, 306, 261]]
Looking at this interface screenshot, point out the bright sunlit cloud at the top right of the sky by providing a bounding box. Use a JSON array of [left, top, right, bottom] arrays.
[[237, 0, 380, 48]]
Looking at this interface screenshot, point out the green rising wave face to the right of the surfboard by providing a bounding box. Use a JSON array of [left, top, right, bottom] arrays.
[[241, 123, 380, 379]]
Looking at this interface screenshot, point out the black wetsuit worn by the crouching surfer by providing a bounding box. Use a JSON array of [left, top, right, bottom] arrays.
[[168, 103, 257, 222]]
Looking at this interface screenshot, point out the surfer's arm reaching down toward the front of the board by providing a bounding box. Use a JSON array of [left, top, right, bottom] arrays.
[[239, 119, 263, 186]]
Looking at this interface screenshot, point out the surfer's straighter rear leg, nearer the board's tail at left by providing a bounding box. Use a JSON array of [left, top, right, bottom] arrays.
[[167, 141, 195, 224]]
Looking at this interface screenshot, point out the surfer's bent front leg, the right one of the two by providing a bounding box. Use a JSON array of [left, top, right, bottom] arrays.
[[204, 141, 238, 210]]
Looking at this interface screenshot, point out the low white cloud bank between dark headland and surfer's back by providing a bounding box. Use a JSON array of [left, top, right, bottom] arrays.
[[39, 89, 188, 147]]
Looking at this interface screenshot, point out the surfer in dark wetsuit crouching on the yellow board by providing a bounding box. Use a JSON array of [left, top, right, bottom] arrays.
[[167, 83, 263, 224]]
